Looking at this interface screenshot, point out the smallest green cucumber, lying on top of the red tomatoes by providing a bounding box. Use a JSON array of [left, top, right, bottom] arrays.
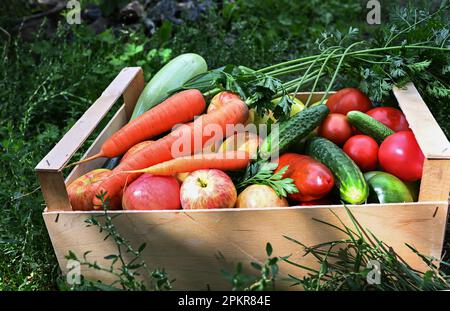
[[347, 110, 394, 144]]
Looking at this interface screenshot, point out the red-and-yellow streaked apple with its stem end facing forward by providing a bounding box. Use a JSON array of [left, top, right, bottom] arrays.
[[180, 169, 237, 209]]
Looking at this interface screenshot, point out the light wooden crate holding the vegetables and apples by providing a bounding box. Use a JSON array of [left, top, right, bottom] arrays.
[[36, 67, 450, 290]]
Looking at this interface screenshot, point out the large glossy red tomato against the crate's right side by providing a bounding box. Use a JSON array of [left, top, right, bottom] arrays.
[[378, 131, 425, 181]]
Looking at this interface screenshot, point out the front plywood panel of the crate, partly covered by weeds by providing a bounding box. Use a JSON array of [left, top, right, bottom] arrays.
[[44, 202, 448, 290]]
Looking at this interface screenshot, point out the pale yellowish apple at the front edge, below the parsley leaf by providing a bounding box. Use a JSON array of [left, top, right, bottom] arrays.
[[236, 185, 289, 208]]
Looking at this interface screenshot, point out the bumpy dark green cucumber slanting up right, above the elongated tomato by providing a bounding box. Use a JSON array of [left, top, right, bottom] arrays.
[[259, 105, 330, 159]]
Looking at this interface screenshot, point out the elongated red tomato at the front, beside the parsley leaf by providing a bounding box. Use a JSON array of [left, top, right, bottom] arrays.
[[275, 153, 334, 202]]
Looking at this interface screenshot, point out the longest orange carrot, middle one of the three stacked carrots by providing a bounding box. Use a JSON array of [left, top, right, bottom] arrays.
[[93, 100, 248, 206]]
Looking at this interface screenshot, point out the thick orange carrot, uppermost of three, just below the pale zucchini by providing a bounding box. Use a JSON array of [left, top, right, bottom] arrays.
[[69, 89, 206, 166]]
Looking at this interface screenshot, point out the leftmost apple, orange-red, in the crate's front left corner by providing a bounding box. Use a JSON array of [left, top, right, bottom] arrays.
[[67, 168, 120, 211]]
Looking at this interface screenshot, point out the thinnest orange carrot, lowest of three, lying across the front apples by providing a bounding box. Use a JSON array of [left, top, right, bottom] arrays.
[[122, 151, 250, 176]]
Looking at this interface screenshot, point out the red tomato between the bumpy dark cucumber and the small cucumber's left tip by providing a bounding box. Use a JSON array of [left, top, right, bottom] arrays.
[[318, 113, 352, 145]]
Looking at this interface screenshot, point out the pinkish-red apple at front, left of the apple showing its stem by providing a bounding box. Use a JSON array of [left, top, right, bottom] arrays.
[[122, 174, 180, 210]]
